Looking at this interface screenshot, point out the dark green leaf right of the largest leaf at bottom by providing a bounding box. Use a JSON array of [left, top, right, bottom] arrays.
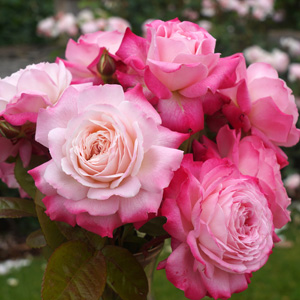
[[102, 245, 148, 300]]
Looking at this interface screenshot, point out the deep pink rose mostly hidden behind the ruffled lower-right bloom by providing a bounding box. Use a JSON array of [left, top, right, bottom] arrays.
[[194, 126, 291, 228]]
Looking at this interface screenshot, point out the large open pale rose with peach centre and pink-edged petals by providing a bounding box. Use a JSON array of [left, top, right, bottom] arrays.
[[29, 85, 187, 237]]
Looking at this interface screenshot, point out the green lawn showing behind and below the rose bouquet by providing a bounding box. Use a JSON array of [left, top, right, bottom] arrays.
[[0, 207, 300, 300]]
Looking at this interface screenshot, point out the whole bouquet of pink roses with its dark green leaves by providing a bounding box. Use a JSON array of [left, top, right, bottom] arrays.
[[0, 19, 300, 300]]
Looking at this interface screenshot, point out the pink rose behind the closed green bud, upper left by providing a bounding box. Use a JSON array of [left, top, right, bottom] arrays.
[[57, 31, 124, 85]]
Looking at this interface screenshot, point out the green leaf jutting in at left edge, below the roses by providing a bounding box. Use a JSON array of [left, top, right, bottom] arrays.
[[0, 197, 36, 218]]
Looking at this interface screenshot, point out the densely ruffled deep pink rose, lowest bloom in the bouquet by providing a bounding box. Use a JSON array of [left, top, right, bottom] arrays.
[[158, 154, 274, 300]]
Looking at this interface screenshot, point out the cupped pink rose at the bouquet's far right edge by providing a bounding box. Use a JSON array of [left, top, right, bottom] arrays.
[[220, 63, 300, 151]]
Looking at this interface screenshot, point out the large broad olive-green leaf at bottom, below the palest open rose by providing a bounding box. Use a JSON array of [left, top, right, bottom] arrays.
[[42, 241, 106, 300]]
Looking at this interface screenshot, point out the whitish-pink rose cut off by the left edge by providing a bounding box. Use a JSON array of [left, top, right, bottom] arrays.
[[0, 62, 72, 126]]
